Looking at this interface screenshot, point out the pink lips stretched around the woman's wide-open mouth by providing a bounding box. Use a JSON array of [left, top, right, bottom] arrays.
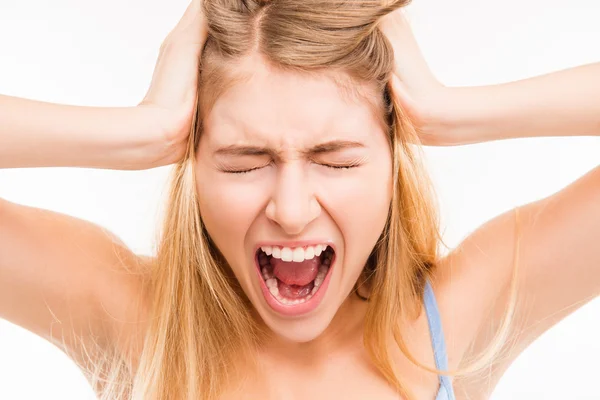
[[254, 241, 337, 317]]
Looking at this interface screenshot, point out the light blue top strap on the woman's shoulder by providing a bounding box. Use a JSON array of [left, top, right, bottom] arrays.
[[424, 281, 456, 400]]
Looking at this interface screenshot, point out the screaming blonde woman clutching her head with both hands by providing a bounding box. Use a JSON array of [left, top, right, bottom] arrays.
[[0, 0, 600, 399]]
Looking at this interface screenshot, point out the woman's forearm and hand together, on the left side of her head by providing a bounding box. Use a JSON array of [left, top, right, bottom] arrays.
[[0, 0, 208, 170]]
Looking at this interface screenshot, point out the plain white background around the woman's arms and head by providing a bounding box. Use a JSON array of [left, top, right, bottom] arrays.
[[0, 0, 600, 400]]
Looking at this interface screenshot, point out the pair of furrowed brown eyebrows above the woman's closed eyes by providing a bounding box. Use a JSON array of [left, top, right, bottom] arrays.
[[215, 140, 365, 160]]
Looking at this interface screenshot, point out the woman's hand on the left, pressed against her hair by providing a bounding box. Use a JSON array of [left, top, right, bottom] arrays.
[[138, 0, 208, 165]]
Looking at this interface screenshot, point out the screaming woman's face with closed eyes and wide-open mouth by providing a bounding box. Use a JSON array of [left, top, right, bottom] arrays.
[[197, 63, 392, 342]]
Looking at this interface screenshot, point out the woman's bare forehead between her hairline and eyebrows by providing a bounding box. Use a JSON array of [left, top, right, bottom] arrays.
[[203, 63, 384, 147]]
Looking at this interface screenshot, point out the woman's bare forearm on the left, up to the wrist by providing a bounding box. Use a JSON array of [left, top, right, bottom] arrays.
[[0, 96, 169, 169]]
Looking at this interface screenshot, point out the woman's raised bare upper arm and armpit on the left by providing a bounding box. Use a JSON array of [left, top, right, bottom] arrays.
[[0, 199, 151, 376]]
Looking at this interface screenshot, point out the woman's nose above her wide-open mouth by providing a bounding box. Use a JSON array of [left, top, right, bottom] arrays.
[[265, 165, 321, 235]]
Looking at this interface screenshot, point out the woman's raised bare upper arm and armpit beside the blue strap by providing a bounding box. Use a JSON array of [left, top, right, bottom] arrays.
[[432, 168, 600, 398]]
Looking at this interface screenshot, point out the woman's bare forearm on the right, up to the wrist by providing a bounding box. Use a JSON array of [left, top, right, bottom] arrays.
[[432, 63, 600, 144]]
